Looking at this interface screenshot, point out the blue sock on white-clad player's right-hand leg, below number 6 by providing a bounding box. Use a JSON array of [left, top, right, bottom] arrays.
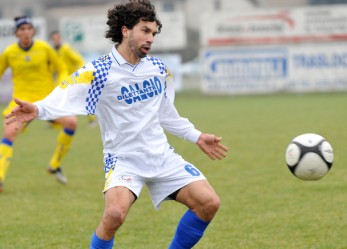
[[169, 209, 210, 249]]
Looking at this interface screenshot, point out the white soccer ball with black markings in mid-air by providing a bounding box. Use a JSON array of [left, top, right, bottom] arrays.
[[286, 133, 334, 181]]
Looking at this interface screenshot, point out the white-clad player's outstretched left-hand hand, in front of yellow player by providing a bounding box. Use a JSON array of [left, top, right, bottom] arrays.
[[5, 98, 38, 129]]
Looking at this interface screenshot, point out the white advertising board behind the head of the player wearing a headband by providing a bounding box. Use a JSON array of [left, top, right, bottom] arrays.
[[0, 18, 47, 52]]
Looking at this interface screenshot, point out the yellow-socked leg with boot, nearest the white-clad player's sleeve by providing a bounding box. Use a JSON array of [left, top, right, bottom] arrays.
[[48, 116, 77, 184]]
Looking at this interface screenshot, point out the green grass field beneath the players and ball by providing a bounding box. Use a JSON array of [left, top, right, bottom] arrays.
[[0, 92, 347, 249]]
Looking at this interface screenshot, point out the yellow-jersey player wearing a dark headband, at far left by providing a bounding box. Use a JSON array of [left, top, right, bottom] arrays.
[[0, 16, 77, 192]]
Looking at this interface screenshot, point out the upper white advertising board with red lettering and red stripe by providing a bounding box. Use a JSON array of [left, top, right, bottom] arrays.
[[201, 5, 347, 46]]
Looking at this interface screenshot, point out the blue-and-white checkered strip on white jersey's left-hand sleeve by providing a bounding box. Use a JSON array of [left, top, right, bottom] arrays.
[[86, 55, 112, 114]]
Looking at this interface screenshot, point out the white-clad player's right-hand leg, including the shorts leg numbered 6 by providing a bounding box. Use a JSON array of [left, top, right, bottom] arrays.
[[146, 148, 220, 249]]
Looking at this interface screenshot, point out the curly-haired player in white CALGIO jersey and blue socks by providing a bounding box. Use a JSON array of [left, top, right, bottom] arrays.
[[6, 0, 228, 249]]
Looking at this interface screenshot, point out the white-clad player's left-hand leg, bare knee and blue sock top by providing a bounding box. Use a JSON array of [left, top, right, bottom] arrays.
[[90, 186, 136, 249]]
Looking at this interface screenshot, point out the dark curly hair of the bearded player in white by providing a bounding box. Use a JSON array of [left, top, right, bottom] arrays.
[[105, 0, 162, 43]]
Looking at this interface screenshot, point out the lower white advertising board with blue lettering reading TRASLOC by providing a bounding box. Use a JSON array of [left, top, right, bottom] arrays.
[[202, 43, 347, 95]]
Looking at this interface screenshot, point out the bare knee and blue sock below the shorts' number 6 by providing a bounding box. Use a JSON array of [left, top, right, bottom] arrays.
[[169, 180, 220, 249]]
